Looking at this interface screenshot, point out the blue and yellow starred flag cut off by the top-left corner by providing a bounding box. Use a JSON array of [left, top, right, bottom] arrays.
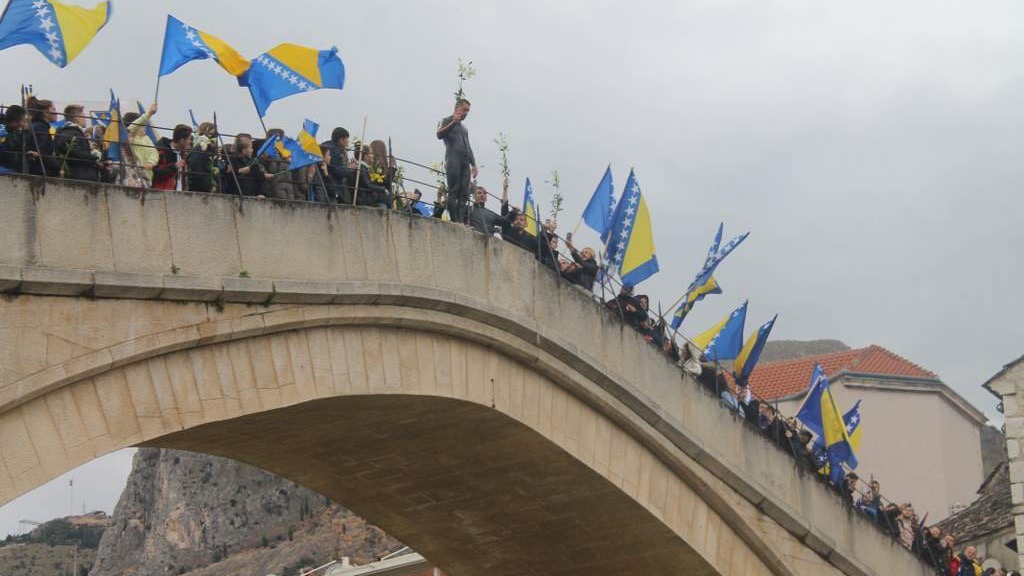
[[0, 0, 114, 68]]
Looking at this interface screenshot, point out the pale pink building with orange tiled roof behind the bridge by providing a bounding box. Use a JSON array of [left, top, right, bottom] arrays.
[[751, 345, 987, 523]]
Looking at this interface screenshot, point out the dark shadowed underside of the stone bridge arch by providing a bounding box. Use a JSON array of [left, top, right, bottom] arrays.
[[147, 396, 718, 576]]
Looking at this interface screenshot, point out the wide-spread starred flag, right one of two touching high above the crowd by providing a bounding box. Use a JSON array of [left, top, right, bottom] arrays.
[[239, 44, 345, 117]]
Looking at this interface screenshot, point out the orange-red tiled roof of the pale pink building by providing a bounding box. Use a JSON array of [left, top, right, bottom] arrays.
[[751, 344, 938, 400]]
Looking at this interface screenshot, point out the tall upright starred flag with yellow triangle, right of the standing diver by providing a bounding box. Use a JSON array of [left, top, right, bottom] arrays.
[[607, 170, 659, 286]]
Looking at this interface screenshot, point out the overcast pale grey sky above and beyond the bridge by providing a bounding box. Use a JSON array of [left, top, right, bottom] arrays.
[[0, 0, 1024, 533]]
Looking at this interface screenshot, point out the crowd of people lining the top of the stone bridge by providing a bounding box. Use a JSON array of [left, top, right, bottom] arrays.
[[0, 93, 1019, 576]]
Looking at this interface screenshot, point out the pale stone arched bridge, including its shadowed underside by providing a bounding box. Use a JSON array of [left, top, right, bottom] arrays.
[[0, 177, 929, 576]]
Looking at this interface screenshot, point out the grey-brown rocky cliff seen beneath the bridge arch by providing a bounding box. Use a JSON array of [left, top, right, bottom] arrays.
[[90, 448, 400, 576]]
